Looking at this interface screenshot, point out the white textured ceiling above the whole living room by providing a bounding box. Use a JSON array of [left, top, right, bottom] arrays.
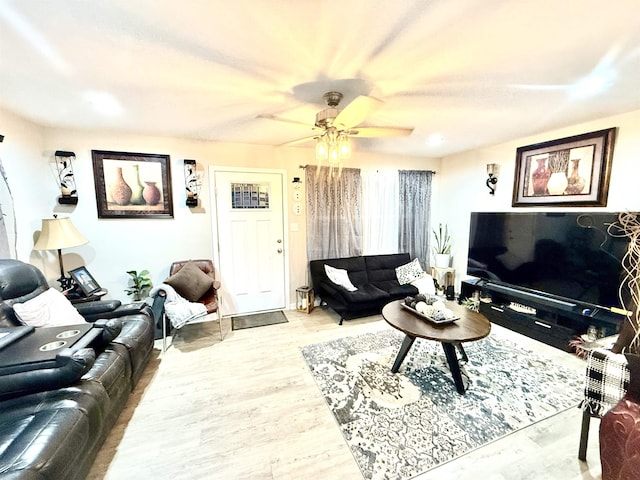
[[0, 0, 640, 157]]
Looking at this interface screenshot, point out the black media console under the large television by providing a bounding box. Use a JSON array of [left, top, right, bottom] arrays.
[[460, 279, 624, 351]]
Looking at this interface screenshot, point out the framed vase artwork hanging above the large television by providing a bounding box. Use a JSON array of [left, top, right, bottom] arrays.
[[512, 128, 616, 207]]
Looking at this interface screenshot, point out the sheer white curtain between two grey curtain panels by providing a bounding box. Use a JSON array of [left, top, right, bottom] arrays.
[[361, 170, 399, 255]]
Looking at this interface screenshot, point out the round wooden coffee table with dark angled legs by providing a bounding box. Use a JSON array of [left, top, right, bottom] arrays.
[[382, 300, 491, 394]]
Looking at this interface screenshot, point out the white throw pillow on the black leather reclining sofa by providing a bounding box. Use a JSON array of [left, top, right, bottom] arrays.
[[13, 288, 85, 327]]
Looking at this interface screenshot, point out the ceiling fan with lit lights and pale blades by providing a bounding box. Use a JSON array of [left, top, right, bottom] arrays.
[[261, 92, 413, 152]]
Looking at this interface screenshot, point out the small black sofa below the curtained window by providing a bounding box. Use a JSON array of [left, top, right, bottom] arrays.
[[309, 253, 418, 325]]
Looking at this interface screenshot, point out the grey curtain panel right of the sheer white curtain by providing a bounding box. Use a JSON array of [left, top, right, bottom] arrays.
[[398, 170, 433, 269]]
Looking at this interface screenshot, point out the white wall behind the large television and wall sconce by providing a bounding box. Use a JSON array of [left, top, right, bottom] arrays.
[[434, 111, 640, 285]]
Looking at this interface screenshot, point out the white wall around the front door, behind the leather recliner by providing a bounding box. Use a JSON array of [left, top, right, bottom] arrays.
[[0, 109, 440, 301]]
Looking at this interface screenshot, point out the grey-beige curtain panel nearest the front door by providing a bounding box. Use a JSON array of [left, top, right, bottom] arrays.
[[306, 167, 362, 260]]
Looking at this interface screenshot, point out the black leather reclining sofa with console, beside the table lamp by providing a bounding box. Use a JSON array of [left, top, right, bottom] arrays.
[[0, 260, 154, 480]]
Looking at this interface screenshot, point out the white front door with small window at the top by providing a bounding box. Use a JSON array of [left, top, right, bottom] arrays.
[[210, 167, 286, 315]]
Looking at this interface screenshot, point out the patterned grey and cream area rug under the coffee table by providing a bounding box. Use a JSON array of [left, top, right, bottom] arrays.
[[302, 330, 584, 479]]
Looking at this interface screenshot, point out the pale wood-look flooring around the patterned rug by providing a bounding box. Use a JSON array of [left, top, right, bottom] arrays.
[[88, 308, 601, 480]]
